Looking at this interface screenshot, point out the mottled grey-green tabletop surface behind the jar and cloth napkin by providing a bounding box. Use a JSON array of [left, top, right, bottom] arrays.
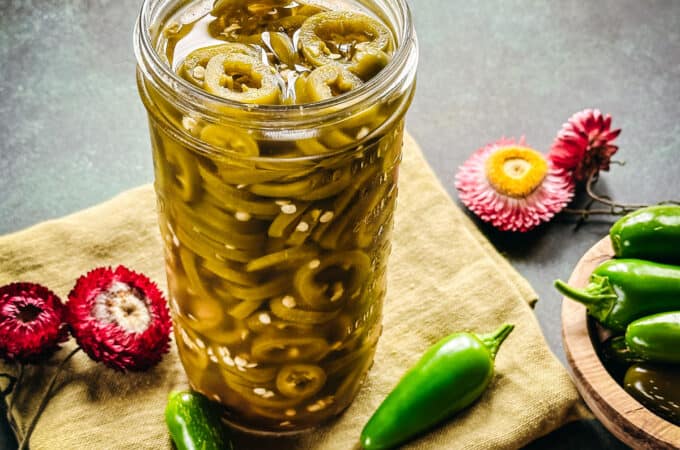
[[0, 0, 680, 448]]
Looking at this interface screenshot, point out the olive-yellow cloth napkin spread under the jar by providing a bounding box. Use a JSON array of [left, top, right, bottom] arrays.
[[0, 136, 582, 450]]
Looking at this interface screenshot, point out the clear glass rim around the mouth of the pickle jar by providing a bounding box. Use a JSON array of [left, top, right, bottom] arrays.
[[133, 0, 417, 128]]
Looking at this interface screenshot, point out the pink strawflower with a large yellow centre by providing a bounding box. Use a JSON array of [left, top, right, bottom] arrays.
[[456, 138, 574, 232]]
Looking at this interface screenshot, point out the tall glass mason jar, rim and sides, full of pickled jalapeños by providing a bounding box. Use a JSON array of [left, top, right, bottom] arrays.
[[134, 0, 418, 433]]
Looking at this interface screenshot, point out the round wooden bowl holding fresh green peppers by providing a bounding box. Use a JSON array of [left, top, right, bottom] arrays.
[[562, 237, 680, 449]]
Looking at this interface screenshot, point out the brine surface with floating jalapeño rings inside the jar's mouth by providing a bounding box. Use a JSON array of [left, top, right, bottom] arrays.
[[158, 0, 394, 104]]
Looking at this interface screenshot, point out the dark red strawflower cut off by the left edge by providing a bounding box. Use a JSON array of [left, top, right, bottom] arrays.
[[0, 283, 68, 363]]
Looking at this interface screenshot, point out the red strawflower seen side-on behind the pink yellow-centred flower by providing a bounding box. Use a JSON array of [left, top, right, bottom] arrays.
[[548, 109, 621, 181]]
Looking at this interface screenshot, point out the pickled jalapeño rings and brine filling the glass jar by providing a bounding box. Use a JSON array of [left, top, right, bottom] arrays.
[[140, 0, 412, 432]]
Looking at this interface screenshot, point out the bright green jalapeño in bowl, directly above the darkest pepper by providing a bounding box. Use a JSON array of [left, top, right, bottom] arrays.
[[608, 311, 680, 366]]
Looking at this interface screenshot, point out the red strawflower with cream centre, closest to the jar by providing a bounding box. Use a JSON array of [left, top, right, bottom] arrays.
[[67, 266, 171, 372]]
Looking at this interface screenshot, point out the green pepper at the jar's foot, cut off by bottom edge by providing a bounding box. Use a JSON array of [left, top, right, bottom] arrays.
[[165, 391, 234, 450]]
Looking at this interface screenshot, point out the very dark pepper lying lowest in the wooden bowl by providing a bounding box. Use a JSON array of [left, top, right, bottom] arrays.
[[623, 364, 680, 425]]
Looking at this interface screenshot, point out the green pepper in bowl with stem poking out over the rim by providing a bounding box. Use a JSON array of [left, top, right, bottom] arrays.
[[555, 259, 680, 333]]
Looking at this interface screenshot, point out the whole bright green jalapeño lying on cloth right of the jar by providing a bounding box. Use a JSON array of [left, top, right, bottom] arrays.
[[361, 324, 514, 450]]
